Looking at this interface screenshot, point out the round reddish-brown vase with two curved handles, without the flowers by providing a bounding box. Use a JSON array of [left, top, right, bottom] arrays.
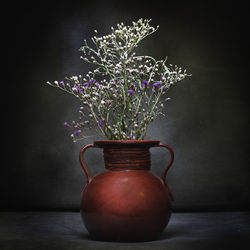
[[80, 140, 174, 241]]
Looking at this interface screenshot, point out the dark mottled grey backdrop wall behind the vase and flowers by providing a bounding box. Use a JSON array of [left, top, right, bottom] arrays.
[[0, 1, 250, 211]]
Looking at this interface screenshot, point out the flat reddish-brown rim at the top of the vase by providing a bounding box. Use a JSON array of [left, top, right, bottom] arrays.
[[94, 140, 160, 147]]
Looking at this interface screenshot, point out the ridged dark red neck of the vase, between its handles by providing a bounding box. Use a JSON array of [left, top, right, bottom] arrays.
[[104, 147, 150, 170]]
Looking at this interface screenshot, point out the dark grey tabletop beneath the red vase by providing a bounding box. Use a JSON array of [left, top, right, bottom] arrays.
[[0, 212, 250, 250]]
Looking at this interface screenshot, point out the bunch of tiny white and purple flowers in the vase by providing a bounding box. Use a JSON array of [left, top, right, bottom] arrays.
[[47, 19, 189, 142]]
